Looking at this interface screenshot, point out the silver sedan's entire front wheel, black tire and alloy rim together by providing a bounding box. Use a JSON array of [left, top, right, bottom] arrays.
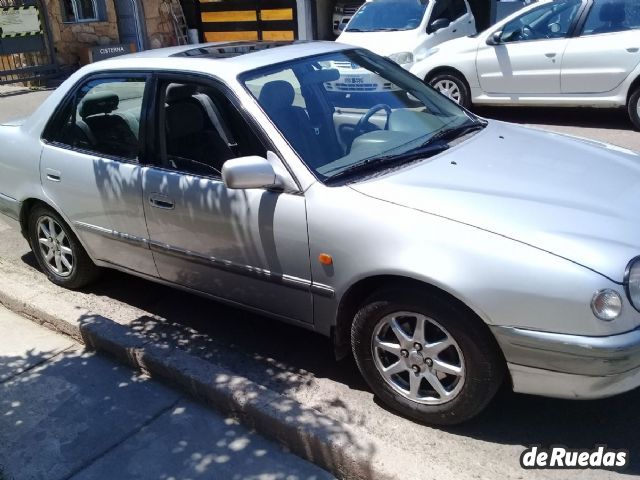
[[351, 289, 505, 425]]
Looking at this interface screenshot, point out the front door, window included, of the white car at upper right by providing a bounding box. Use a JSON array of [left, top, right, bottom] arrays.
[[476, 0, 582, 95]]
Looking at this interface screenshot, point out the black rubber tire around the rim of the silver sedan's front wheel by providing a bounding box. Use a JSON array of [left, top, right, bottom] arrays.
[[351, 288, 506, 425]]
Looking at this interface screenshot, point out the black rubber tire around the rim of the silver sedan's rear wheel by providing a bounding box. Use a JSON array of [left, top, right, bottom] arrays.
[[28, 205, 101, 290]]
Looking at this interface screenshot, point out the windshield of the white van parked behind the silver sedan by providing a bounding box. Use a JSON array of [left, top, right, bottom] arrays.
[[346, 0, 429, 32]]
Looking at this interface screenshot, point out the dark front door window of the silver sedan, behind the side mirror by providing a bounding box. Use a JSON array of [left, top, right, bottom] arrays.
[[158, 82, 266, 178]]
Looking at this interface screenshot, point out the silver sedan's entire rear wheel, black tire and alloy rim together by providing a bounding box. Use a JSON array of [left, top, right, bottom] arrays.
[[29, 206, 100, 289]]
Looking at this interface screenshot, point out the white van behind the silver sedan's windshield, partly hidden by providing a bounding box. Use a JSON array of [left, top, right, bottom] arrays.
[[336, 0, 476, 70]]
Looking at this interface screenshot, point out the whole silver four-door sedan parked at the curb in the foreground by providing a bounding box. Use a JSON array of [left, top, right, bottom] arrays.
[[0, 42, 640, 424]]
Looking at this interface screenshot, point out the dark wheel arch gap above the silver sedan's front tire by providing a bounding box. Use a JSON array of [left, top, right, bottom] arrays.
[[332, 274, 502, 359]]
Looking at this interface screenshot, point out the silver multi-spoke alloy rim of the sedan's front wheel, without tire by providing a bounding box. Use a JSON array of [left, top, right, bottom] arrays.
[[371, 312, 465, 405]]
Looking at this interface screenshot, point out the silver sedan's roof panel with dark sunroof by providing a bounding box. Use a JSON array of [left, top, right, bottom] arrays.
[[85, 41, 356, 78]]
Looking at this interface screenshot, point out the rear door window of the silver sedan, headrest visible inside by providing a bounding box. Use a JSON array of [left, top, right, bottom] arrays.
[[46, 77, 146, 161]]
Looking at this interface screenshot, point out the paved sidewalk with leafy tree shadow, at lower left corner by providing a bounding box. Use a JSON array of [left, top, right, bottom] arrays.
[[0, 306, 338, 480]]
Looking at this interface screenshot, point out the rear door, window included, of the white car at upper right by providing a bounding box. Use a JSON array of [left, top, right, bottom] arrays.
[[561, 0, 640, 93]]
